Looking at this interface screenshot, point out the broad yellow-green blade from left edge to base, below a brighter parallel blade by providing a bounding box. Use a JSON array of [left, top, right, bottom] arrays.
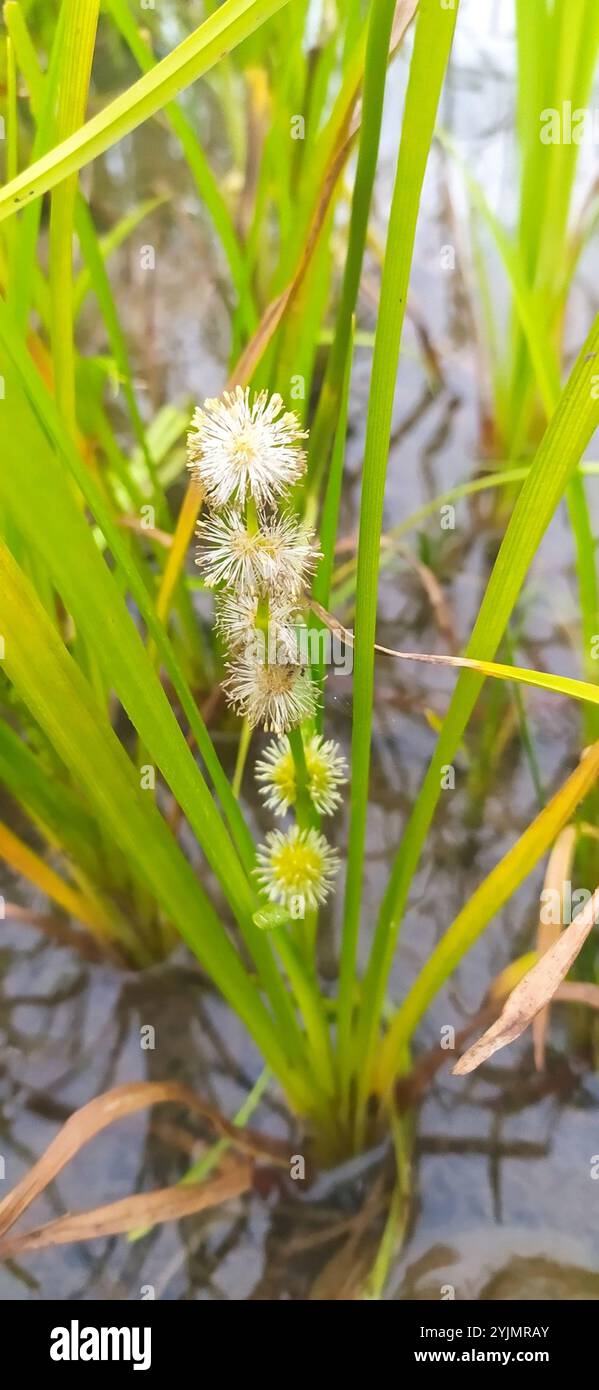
[[0, 541, 307, 1087]]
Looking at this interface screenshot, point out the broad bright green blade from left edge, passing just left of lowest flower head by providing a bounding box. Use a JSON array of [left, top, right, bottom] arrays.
[[0, 353, 314, 1047]]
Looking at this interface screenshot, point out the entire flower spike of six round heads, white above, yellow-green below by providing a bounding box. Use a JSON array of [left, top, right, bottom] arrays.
[[188, 386, 346, 917]]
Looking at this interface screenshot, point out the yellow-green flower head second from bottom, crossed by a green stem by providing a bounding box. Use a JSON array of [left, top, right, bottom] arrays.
[[256, 734, 347, 816]]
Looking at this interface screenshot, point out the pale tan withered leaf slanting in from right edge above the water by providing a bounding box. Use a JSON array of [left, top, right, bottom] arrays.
[[453, 888, 599, 1076]]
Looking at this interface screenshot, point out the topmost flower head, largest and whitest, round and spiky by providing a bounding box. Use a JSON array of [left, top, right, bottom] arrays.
[[188, 386, 307, 507]]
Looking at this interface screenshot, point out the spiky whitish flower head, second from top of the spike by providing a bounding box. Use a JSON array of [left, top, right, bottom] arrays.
[[196, 507, 320, 599]]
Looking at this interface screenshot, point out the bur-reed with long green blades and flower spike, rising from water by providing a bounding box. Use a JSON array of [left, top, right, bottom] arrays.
[[0, 0, 599, 1173]]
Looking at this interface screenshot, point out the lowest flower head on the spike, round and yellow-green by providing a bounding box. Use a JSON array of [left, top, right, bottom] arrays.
[[254, 826, 339, 917]]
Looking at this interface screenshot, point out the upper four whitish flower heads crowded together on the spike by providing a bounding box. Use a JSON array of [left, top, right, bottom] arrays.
[[188, 386, 318, 734]]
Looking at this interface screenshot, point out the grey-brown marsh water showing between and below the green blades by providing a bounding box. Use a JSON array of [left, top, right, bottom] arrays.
[[0, 0, 599, 1300]]
